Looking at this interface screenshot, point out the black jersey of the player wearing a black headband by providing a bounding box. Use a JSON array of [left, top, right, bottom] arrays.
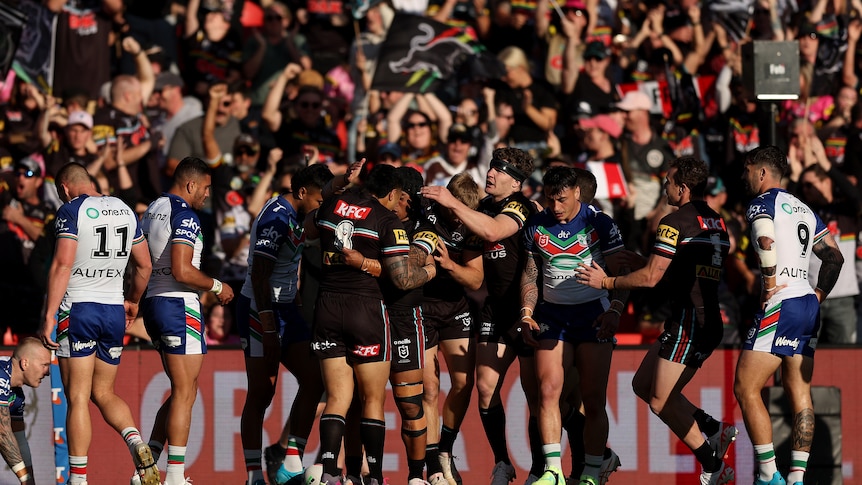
[[479, 192, 536, 301]]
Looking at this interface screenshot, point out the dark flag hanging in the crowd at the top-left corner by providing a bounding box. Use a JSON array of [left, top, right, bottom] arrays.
[[14, 0, 57, 92]]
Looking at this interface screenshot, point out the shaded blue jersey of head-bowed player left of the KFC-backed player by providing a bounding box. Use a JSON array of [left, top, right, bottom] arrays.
[[241, 196, 305, 303]]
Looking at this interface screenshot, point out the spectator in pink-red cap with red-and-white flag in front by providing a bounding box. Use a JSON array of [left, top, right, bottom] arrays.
[[578, 115, 626, 217]]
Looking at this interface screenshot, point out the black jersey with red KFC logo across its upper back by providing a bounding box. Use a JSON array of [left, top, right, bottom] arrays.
[[314, 190, 410, 300]]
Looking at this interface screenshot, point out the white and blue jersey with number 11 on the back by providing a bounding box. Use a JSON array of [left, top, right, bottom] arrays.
[[55, 195, 144, 302]]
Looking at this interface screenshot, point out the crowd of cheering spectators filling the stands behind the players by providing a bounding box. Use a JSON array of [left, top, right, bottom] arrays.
[[0, 0, 862, 344]]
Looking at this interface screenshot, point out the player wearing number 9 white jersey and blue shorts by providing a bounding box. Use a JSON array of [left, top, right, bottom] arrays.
[[733, 146, 844, 485]]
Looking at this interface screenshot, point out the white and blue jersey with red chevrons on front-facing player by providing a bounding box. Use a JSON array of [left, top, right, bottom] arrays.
[[524, 204, 624, 305]]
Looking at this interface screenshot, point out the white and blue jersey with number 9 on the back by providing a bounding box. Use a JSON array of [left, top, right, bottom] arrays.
[[745, 189, 829, 300]]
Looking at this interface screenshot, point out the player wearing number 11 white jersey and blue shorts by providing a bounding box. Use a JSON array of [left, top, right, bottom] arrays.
[[42, 163, 159, 485]]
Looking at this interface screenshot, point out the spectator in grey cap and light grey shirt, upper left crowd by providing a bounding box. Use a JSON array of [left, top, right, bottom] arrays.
[[153, 71, 203, 164]]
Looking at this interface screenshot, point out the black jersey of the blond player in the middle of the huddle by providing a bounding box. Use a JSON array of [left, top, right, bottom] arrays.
[[417, 204, 482, 301]]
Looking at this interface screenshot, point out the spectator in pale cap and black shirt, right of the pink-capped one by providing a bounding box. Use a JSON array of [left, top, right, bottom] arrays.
[[617, 91, 673, 254]]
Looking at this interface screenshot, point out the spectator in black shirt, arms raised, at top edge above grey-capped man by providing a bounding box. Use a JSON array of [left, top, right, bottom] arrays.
[[180, 0, 242, 97]]
